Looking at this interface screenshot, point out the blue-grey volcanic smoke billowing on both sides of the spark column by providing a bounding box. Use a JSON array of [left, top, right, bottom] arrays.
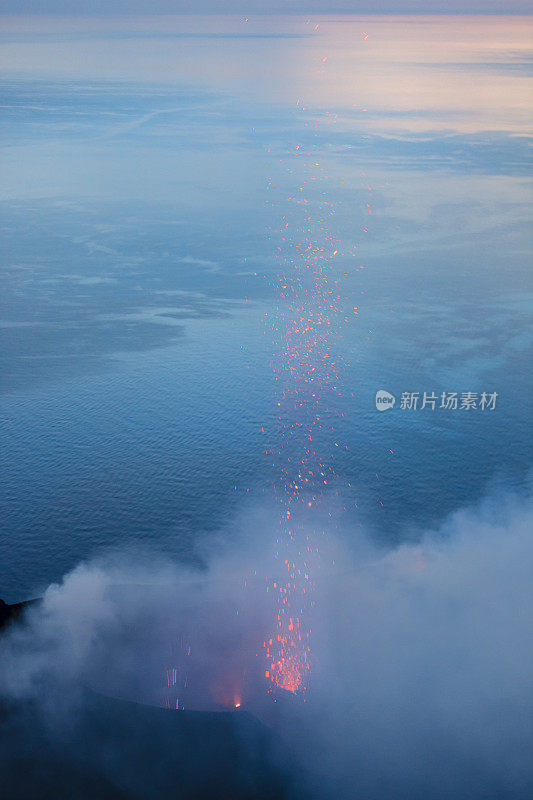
[[0, 488, 533, 800]]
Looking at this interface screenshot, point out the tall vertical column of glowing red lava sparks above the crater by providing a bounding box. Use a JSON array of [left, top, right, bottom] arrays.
[[264, 103, 353, 693]]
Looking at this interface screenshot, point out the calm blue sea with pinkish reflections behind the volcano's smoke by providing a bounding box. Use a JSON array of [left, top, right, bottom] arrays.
[[0, 17, 532, 601]]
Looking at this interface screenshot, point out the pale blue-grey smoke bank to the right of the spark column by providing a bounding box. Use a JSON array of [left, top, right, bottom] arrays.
[[298, 488, 533, 799]]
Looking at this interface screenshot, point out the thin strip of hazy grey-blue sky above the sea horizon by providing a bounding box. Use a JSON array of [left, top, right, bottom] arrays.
[[1, 0, 533, 14]]
